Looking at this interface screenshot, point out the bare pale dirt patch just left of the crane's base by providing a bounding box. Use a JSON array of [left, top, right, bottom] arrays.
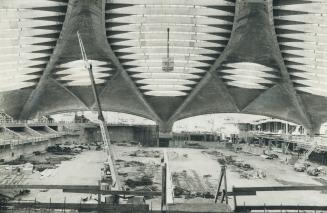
[[19, 150, 106, 203]]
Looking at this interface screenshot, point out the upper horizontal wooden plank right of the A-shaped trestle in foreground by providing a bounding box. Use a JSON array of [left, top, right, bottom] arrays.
[[234, 185, 327, 193]]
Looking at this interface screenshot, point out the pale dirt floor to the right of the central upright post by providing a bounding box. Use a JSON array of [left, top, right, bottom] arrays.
[[169, 148, 327, 209]]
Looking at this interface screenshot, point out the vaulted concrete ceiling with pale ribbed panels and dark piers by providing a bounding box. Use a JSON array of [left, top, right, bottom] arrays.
[[0, 0, 327, 132]]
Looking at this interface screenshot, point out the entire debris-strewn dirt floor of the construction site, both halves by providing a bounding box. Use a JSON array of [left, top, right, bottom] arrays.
[[0, 143, 327, 210]]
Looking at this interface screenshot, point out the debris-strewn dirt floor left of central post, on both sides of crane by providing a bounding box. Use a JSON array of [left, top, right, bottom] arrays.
[[0, 146, 162, 209]]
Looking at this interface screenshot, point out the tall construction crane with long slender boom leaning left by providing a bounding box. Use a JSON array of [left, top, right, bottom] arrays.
[[77, 31, 122, 190]]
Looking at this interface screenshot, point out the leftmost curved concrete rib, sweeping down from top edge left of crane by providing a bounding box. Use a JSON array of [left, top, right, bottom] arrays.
[[19, 0, 77, 119]]
